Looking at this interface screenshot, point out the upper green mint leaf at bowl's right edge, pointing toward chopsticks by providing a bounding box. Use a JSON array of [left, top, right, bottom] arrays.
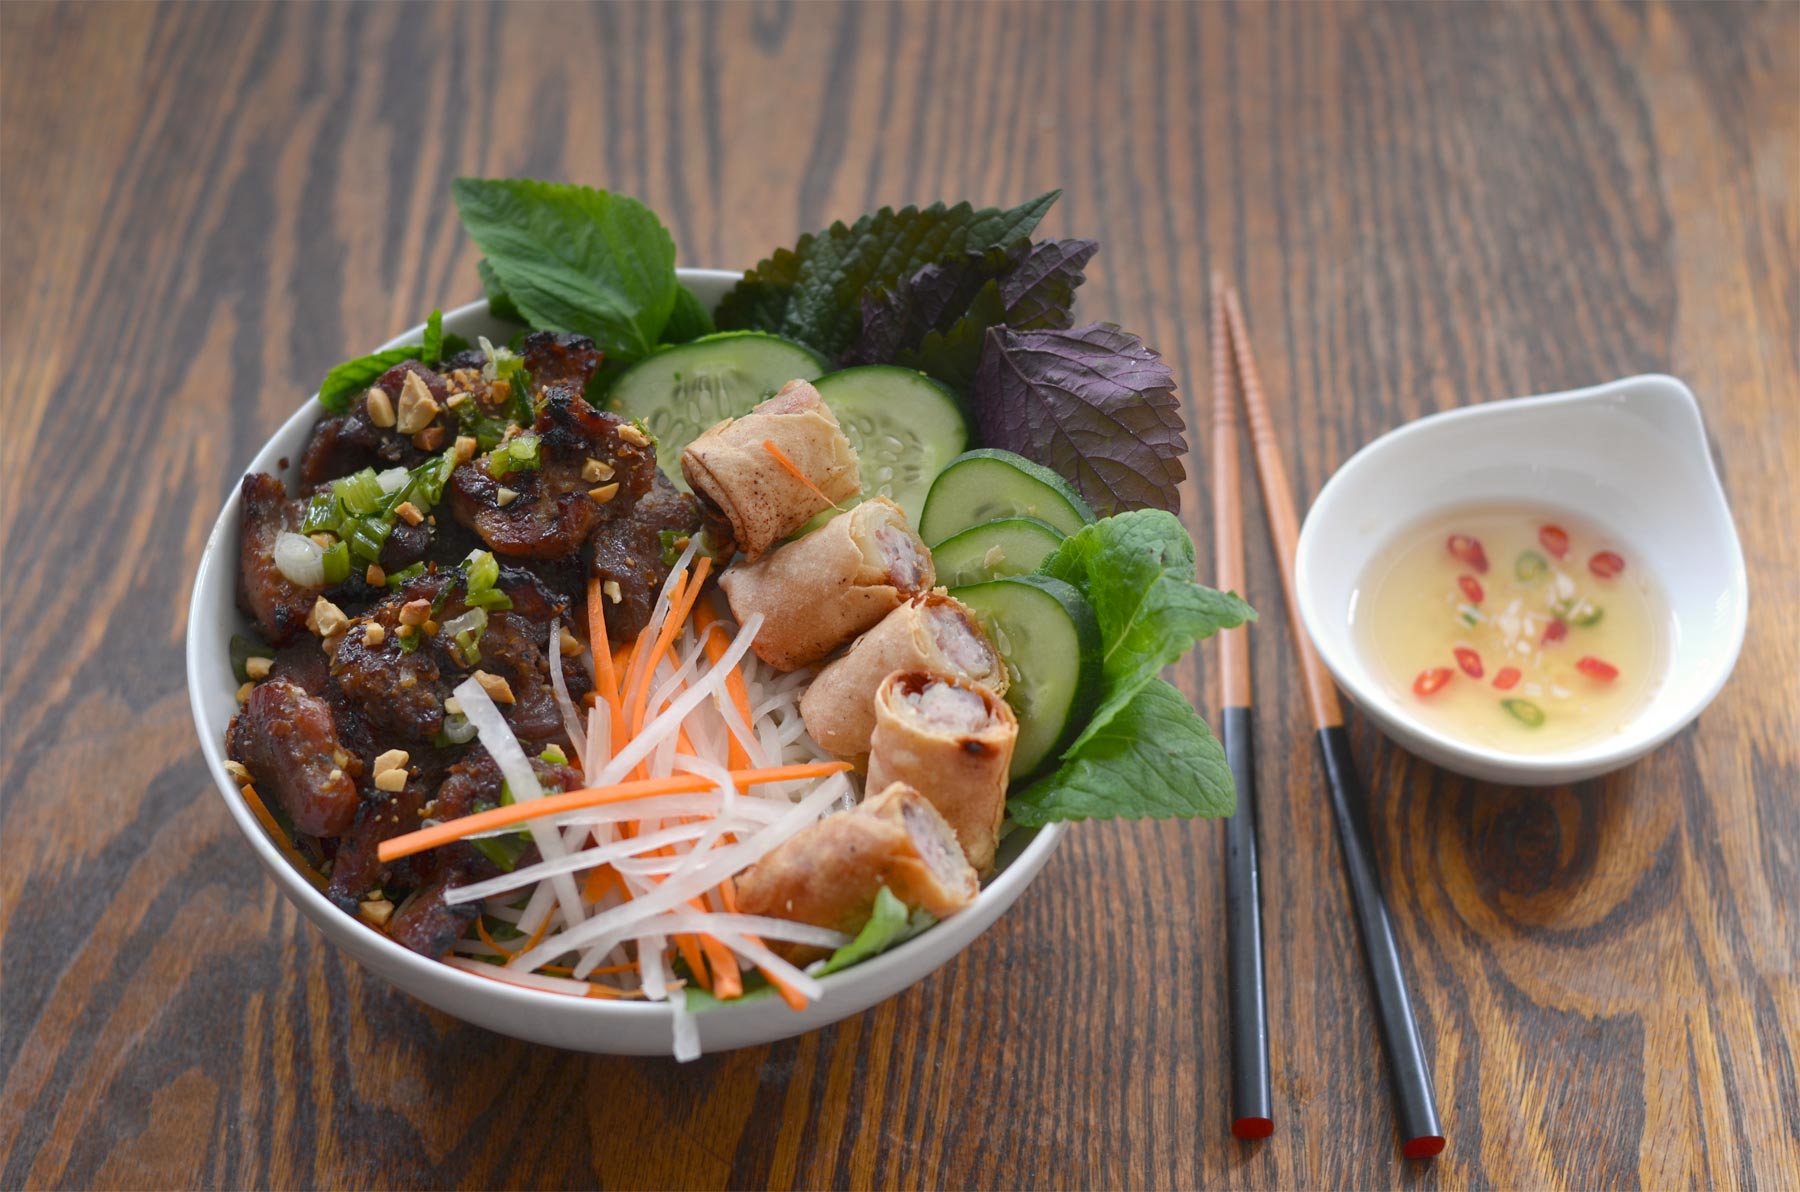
[[1039, 510, 1256, 758]]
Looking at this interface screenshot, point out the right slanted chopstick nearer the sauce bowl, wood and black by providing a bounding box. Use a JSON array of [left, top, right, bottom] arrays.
[[1224, 277, 1444, 1160]]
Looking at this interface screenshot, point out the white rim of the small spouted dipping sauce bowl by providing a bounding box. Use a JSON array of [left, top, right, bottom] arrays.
[[1294, 373, 1750, 781]]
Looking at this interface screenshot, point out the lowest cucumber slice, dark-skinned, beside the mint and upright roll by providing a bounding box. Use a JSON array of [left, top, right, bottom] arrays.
[[950, 576, 1100, 780]]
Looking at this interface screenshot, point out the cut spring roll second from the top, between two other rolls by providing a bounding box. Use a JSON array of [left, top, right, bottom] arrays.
[[718, 497, 936, 670]]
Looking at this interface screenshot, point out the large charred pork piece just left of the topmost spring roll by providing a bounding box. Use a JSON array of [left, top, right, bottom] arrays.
[[450, 385, 657, 558]]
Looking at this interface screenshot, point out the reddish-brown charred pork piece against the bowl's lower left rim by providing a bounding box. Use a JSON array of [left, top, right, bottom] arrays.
[[225, 679, 362, 835]]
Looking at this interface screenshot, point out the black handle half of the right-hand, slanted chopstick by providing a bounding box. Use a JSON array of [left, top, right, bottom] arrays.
[[1319, 724, 1444, 1160]]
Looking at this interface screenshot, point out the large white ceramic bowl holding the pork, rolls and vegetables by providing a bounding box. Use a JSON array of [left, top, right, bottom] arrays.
[[187, 268, 1064, 1055]]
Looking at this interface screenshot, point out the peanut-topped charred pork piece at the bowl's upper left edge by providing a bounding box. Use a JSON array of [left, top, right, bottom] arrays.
[[301, 360, 455, 492]]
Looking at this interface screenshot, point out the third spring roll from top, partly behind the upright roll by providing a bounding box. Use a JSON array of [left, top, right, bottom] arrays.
[[799, 591, 1006, 769]]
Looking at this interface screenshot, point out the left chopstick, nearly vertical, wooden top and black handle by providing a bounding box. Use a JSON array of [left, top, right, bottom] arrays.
[[1211, 274, 1274, 1138]]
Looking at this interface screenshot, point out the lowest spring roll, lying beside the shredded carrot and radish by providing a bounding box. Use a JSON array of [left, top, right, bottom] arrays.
[[736, 781, 981, 963]]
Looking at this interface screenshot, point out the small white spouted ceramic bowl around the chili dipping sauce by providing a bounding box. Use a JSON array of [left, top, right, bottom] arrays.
[[1294, 376, 1750, 785]]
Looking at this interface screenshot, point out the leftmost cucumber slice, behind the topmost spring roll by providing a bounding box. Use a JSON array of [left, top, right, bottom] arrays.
[[607, 331, 824, 492]]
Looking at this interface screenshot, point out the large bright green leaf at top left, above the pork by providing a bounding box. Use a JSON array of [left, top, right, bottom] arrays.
[[450, 178, 679, 362]]
